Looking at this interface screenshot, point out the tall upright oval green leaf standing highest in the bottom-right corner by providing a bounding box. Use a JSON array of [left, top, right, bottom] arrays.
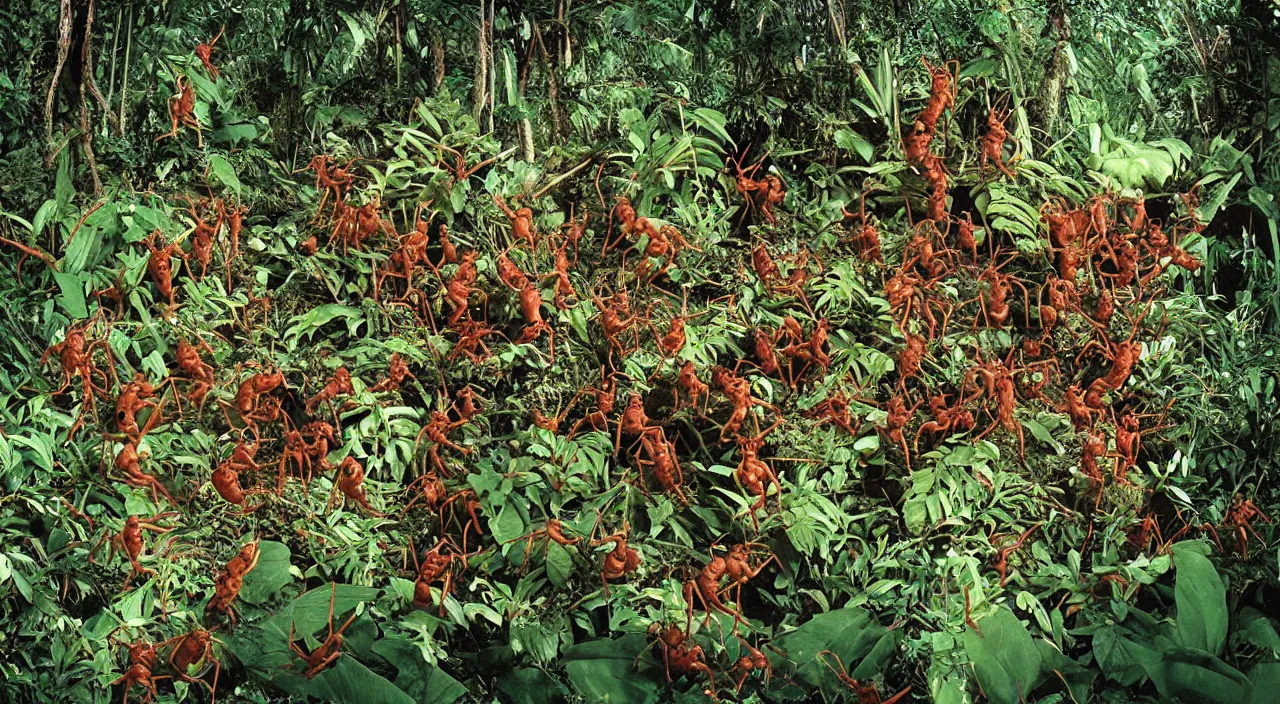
[[1174, 541, 1228, 655]]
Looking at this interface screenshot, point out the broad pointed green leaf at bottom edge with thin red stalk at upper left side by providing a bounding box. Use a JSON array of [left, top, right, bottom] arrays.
[[964, 607, 1042, 704]]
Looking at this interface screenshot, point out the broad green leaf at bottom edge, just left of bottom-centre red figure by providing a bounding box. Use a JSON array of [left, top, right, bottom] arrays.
[[561, 634, 658, 704]]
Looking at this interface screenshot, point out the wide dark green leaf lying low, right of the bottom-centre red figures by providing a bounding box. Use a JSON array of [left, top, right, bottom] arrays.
[[769, 608, 897, 692]]
